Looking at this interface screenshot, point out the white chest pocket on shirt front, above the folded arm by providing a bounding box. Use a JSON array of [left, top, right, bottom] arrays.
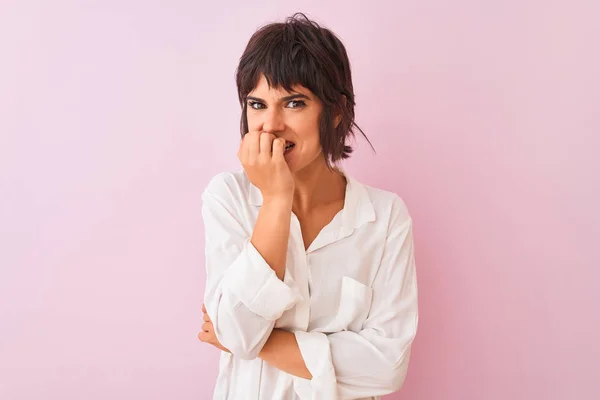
[[316, 276, 373, 332]]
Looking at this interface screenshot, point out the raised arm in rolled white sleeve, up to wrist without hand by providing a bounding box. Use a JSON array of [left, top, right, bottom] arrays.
[[202, 185, 301, 359]]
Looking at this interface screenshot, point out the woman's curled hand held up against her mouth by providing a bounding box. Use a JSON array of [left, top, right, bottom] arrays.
[[238, 131, 294, 198]]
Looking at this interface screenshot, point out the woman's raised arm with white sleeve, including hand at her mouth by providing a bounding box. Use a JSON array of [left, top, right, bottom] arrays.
[[202, 131, 301, 359]]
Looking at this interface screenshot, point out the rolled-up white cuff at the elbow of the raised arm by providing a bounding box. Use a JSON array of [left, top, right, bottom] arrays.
[[222, 240, 302, 321]]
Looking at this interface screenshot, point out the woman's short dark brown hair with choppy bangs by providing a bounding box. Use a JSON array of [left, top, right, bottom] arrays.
[[236, 13, 373, 167]]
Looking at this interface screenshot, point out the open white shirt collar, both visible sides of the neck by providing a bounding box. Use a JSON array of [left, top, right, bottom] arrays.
[[248, 167, 375, 236]]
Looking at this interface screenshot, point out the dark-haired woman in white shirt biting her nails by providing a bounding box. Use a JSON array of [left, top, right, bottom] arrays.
[[198, 14, 418, 400]]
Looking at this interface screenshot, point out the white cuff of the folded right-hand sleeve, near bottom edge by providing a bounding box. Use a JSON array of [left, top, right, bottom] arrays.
[[294, 331, 338, 400]]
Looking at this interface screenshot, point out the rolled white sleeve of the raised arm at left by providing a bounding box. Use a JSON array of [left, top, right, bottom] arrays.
[[202, 191, 302, 359]]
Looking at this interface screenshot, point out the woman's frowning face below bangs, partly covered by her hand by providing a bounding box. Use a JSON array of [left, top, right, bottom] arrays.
[[247, 75, 325, 173]]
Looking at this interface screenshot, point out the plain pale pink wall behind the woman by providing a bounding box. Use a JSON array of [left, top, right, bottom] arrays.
[[0, 0, 600, 400]]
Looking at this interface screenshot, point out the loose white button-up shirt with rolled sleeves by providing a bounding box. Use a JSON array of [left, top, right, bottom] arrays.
[[202, 170, 418, 400]]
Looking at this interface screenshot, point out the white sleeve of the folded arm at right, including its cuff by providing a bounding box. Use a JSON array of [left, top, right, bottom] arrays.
[[294, 198, 418, 400]]
